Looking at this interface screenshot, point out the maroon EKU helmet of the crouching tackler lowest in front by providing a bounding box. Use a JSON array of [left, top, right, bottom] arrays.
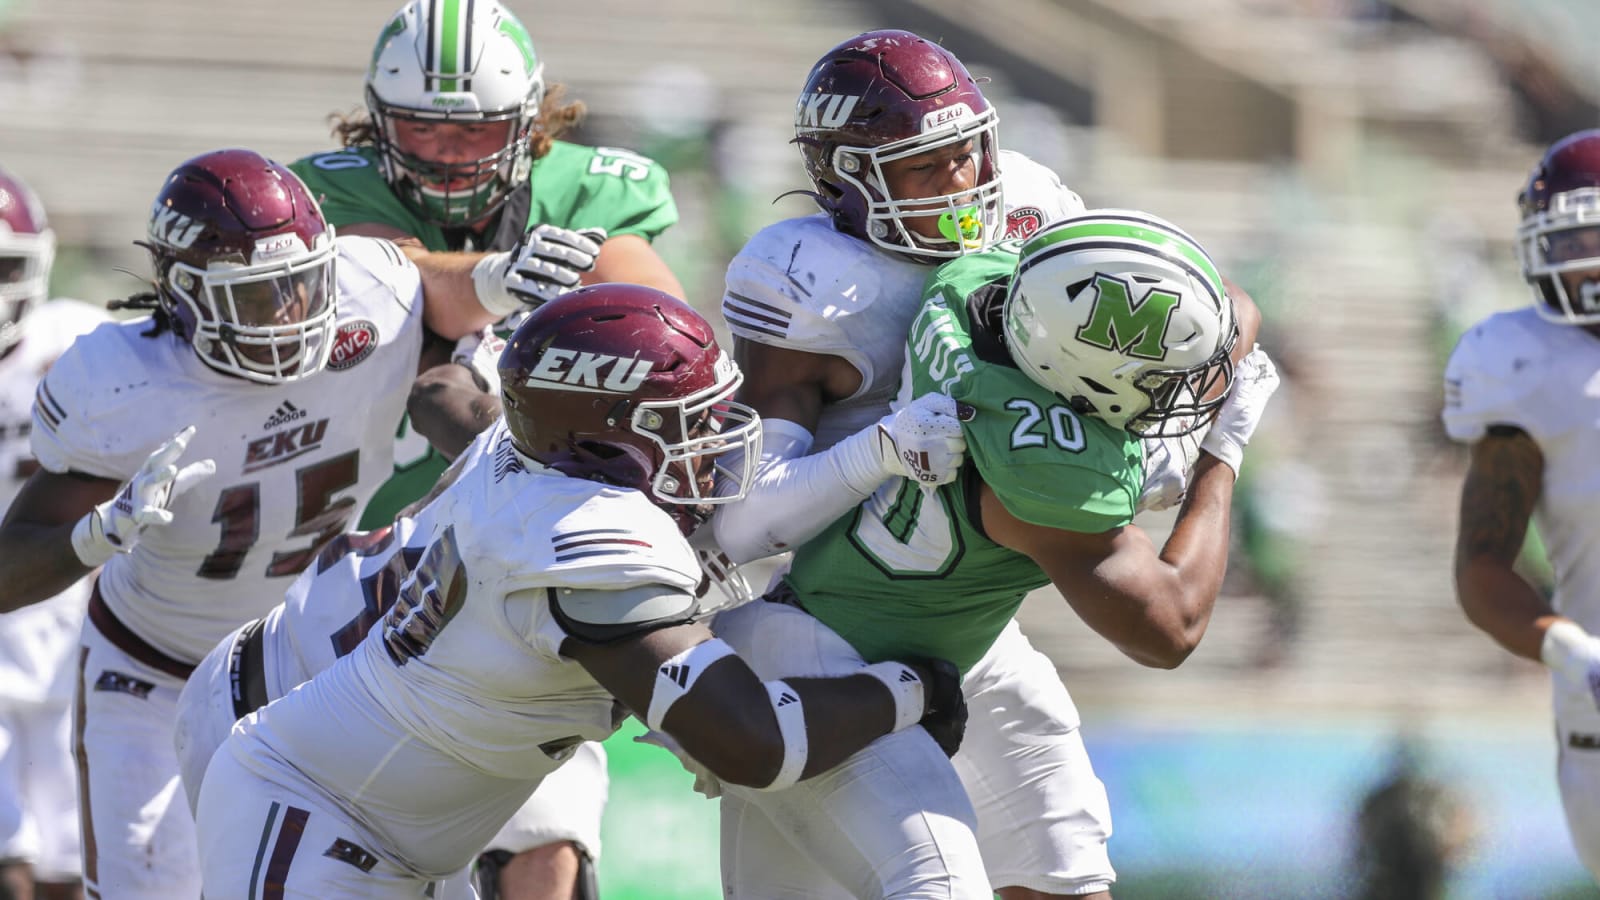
[[499, 283, 762, 533]]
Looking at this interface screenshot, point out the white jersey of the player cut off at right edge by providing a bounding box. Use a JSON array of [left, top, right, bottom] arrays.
[[1443, 306, 1600, 714]]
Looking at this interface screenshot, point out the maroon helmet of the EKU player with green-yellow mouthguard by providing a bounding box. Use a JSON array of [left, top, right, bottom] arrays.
[[795, 30, 1005, 261]]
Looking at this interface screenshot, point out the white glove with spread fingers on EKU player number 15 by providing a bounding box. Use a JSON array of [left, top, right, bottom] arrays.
[[72, 424, 216, 569]]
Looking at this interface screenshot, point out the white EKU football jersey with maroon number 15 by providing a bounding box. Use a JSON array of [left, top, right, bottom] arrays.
[[32, 237, 422, 663]]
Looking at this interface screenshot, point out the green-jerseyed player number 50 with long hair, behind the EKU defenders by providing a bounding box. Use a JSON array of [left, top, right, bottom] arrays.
[[290, 0, 683, 900]]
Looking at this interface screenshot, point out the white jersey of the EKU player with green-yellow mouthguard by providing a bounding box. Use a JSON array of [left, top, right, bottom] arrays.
[[722, 151, 1083, 453]]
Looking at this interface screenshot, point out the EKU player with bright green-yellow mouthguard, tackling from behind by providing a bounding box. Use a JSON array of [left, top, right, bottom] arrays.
[[714, 30, 1254, 900]]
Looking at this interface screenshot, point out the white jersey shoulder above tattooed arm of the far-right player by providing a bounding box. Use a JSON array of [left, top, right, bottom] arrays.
[[1442, 307, 1555, 444]]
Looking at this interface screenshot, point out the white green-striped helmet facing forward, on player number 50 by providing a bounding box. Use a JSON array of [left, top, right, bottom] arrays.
[[366, 0, 544, 226]]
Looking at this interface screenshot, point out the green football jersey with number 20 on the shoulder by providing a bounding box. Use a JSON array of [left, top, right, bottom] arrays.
[[786, 245, 1144, 673]]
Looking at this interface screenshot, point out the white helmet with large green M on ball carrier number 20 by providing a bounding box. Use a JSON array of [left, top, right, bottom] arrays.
[[1003, 210, 1238, 437]]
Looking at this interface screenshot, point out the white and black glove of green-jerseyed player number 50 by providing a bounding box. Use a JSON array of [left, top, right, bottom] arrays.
[[472, 224, 606, 319]]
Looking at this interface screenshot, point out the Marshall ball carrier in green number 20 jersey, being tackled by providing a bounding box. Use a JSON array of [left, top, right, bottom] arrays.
[[717, 210, 1277, 898]]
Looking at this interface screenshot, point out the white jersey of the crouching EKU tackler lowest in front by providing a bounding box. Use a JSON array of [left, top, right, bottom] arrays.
[[227, 421, 701, 878]]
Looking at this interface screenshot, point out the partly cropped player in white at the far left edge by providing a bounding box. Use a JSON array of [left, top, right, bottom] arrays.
[[0, 171, 109, 900]]
